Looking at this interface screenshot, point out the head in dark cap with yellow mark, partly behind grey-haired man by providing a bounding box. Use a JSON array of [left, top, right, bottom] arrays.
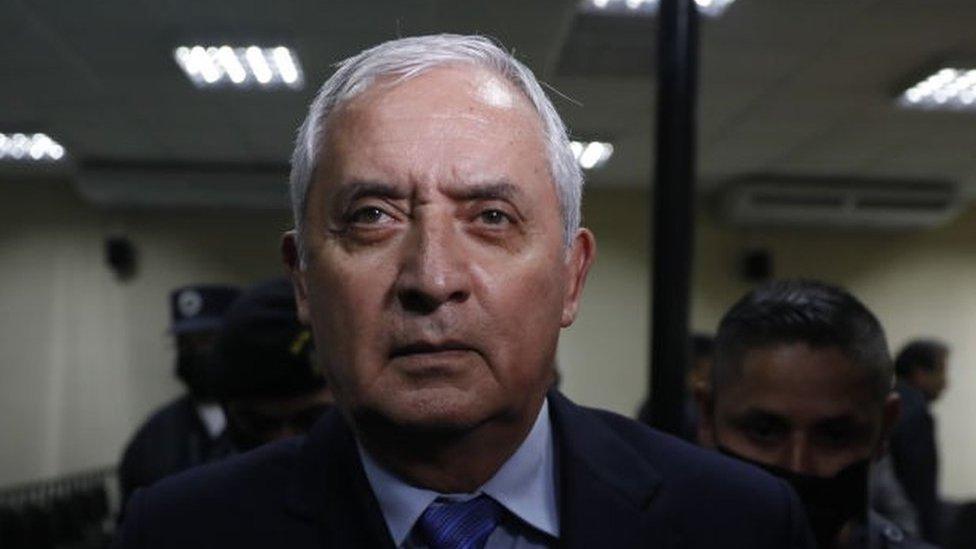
[[214, 278, 332, 452]]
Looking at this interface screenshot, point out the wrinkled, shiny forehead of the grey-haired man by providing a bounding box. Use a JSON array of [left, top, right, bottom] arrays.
[[320, 65, 555, 196]]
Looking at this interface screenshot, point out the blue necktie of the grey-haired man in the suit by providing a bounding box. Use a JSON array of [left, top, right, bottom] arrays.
[[417, 494, 504, 549]]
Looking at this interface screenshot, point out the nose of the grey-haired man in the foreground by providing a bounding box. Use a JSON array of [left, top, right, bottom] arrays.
[[396, 217, 471, 314]]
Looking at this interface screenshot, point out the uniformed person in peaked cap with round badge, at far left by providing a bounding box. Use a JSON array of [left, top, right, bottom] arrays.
[[118, 284, 240, 509]]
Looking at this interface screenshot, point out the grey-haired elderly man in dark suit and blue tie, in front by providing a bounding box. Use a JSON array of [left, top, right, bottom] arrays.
[[114, 35, 810, 549]]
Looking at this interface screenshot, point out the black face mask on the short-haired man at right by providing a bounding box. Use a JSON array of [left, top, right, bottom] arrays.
[[718, 446, 871, 549]]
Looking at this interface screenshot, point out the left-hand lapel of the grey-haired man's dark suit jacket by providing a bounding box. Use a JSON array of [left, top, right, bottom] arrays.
[[289, 410, 394, 549]]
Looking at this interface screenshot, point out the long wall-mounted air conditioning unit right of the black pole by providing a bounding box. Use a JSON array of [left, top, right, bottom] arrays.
[[720, 177, 962, 230]]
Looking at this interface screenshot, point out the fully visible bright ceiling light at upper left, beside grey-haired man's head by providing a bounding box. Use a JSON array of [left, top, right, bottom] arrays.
[[173, 45, 305, 90]]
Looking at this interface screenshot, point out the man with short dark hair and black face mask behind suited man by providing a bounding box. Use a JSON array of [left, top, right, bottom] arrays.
[[697, 281, 928, 549]]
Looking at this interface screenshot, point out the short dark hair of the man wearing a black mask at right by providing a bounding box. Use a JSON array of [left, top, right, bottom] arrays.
[[712, 280, 893, 400]]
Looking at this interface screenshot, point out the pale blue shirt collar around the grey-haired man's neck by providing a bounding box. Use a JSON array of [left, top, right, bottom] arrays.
[[357, 401, 559, 547]]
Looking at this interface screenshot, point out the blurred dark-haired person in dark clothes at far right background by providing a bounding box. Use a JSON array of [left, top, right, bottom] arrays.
[[891, 339, 949, 542]]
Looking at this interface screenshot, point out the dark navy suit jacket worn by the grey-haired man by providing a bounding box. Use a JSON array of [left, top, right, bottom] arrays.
[[116, 392, 812, 549]]
